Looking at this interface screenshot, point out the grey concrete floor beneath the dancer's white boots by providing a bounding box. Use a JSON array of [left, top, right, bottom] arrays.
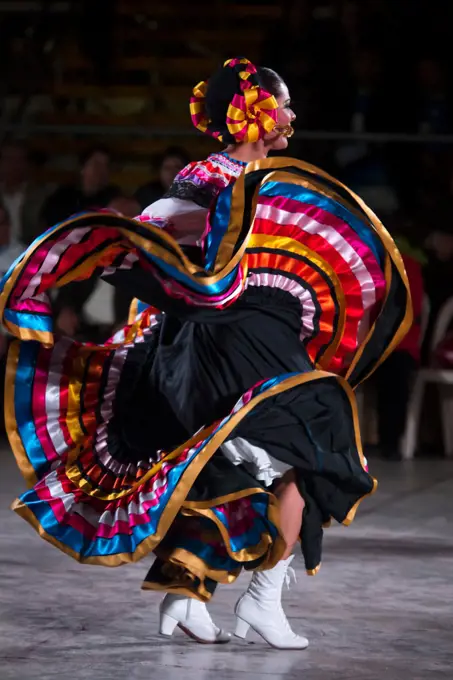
[[0, 449, 453, 680]]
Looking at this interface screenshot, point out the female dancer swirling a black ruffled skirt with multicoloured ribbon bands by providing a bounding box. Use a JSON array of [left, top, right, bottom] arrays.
[[0, 59, 411, 649]]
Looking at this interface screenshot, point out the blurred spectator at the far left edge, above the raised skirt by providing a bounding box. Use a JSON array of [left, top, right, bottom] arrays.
[[0, 141, 49, 244]]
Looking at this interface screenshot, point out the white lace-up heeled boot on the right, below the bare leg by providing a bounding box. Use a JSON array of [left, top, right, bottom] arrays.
[[235, 555, 308, 649]]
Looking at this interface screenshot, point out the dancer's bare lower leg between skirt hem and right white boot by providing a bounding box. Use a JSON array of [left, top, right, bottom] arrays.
[[274, 470, 305, 560]]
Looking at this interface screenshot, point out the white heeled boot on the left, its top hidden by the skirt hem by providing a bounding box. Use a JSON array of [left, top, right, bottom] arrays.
[[159, 593, 231, 644]]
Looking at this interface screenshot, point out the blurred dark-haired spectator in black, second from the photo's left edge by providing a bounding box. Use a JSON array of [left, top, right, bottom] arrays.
[[42, 146, 121, 227]]
